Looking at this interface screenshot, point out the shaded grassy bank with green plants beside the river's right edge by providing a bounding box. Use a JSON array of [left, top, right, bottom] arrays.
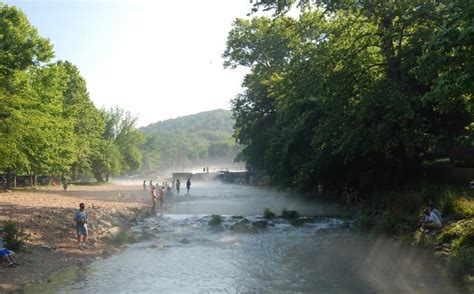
[[350, 184, 474, 291]]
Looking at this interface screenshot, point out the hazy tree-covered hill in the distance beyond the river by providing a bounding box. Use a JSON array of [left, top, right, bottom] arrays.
[[140, 109, 238, 172]]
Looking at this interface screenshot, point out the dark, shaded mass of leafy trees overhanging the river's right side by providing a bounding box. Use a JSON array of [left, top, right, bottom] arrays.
[[228, 0, 474, 189]]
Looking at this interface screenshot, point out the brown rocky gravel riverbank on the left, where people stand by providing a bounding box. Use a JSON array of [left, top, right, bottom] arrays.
[[0, 185, 154, 293]]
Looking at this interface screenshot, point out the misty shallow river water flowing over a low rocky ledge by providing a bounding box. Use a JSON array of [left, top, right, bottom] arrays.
[[25, 184, 463, 293]]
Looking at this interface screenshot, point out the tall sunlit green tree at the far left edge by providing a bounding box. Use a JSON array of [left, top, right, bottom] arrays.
[[0, 4, 53, 185]]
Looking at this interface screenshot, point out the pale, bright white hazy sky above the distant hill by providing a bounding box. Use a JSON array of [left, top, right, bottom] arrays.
[[3, 0, 251, 126]]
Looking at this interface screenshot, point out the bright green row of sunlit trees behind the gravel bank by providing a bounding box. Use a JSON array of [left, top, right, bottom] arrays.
[[0, 3, 145, 186]]
